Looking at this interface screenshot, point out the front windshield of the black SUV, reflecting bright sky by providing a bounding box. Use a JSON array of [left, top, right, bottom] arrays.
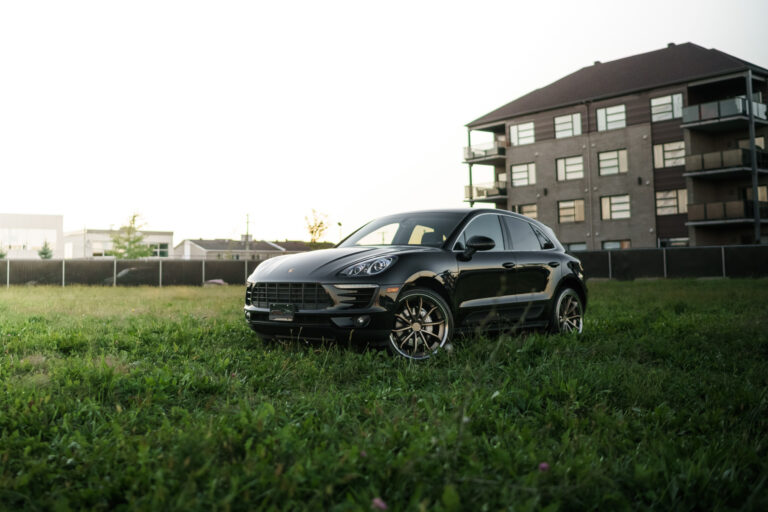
[[339, 212, 466, 247]]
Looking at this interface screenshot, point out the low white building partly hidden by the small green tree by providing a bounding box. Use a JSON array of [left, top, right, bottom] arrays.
[[64, 229, 173, 258]]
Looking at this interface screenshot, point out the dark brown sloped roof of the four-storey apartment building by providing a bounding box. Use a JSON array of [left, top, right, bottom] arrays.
[[467, 43, 768, 128]]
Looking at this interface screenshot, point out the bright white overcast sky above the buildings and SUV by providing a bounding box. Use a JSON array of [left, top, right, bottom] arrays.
[[0, 0, 768, 244]]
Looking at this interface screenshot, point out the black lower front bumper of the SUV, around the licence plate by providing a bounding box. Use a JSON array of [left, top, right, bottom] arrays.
[[243, 284, 400, 344]]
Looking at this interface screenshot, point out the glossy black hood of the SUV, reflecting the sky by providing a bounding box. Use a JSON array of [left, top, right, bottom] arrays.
[[248, 246, 440, 282]]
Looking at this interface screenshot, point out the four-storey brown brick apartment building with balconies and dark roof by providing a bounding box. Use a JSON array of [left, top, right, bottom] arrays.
[[464, 43, 768, 250]]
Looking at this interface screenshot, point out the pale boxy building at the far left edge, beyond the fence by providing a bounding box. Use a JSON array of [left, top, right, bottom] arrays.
[[0, 213, 64, 259]]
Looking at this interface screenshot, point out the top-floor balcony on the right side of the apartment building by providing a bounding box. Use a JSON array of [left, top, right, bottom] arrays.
[[681, 98, 768, 132]]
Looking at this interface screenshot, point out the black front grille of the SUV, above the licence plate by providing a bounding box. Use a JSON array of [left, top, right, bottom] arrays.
[[245, 283, 333, 310]]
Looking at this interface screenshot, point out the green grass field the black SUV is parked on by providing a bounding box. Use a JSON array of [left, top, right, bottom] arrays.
[[0, 280, 768, 511]]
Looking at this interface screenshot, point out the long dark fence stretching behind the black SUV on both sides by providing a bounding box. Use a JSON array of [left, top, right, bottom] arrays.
[[0, 245, 768, 286]]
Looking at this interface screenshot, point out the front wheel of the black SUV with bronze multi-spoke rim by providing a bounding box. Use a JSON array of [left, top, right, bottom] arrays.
[[387, 288, 453, 360]]
